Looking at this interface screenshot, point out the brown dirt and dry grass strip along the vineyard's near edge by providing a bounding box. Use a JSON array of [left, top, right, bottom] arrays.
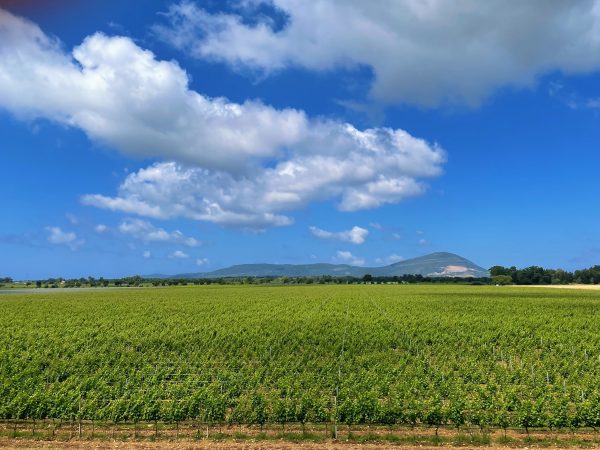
[[0, 421, 600, 450]]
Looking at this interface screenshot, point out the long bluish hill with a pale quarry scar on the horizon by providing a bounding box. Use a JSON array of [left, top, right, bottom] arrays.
[[147, 252, 490, 278]]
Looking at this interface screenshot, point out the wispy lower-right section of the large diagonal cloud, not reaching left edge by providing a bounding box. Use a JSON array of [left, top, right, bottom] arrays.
[[82, 123, 445, 228]]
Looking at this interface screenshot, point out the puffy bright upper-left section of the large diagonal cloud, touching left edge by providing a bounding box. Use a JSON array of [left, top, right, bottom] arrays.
[[0, 10, 308, 171]]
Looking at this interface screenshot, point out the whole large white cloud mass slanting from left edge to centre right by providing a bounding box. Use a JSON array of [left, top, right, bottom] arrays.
[[0, 10, 445, 228]]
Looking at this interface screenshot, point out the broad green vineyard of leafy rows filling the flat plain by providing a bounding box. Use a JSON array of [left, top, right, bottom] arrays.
[[0, 285, 600, 440]]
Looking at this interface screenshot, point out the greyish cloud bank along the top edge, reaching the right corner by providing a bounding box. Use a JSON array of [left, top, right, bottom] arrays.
[[155, 0, 600, 106]]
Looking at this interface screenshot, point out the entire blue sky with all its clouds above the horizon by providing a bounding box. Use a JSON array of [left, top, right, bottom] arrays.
[[0, 0, 600, 279]]
